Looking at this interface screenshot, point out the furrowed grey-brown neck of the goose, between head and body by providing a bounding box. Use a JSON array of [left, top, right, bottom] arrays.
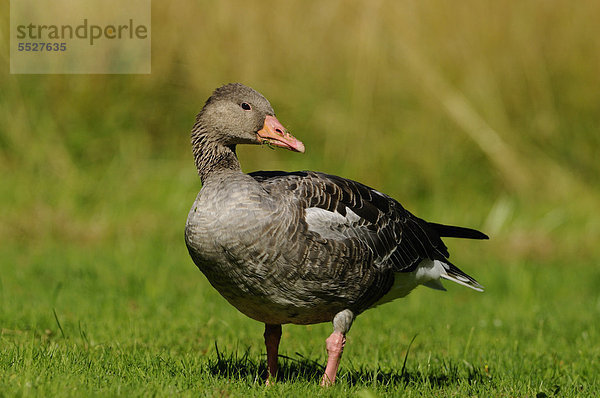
[[192, 130, 242, 184]]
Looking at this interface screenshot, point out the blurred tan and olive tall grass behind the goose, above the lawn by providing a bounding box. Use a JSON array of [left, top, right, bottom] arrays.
[[0, 1, 600, 255]]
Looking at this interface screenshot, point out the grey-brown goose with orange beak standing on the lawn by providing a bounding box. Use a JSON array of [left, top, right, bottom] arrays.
[[185, 83, 488, 385]]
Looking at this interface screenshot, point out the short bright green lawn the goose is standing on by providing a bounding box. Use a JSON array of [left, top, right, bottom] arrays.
[[0, 236, 600, 396]]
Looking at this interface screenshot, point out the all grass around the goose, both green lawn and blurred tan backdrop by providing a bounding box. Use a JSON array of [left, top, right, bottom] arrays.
[[0, 0, 600, 397]]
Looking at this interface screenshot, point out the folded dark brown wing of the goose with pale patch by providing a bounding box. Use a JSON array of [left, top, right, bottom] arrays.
[[250, 171, 452, 279]]
